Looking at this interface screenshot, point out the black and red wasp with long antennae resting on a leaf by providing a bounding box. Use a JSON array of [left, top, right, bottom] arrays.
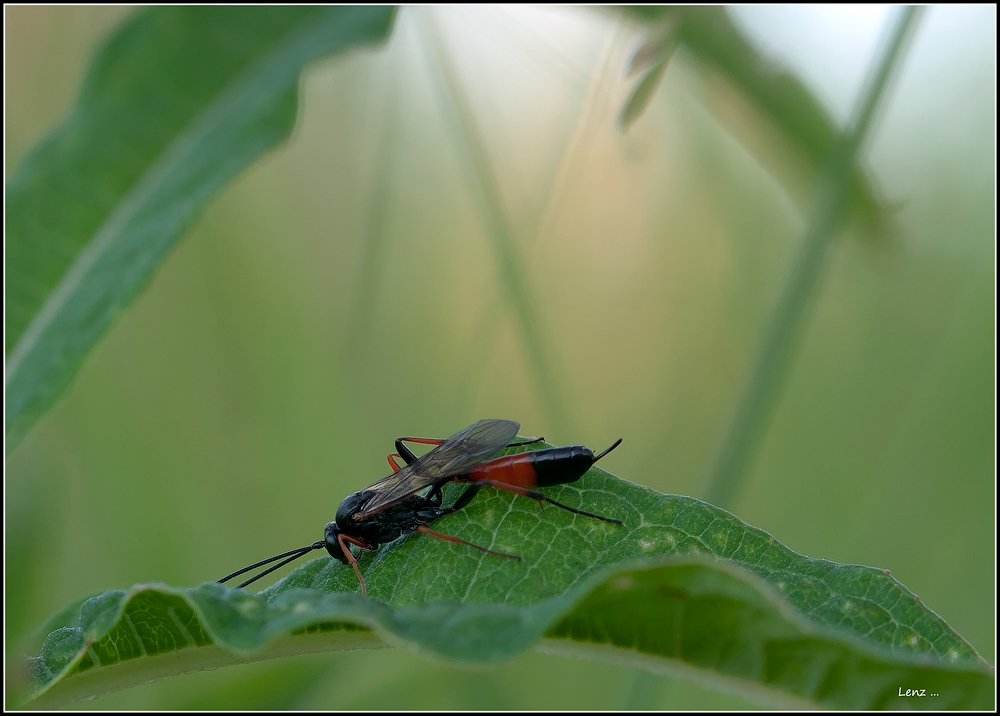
[[219, 420, 621, 594]]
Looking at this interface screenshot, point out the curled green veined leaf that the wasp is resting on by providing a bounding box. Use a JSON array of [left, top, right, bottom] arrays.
[[17, 450, 994, 709]]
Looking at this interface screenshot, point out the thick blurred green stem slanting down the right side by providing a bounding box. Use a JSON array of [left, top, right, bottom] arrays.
[[702, 5, 921, 507]]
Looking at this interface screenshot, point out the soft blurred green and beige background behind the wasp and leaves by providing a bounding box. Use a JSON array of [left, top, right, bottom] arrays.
[[4, 7, 996, 709]]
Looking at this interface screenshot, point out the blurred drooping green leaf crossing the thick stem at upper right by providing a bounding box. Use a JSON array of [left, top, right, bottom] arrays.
[[622, 5, 893, 235]]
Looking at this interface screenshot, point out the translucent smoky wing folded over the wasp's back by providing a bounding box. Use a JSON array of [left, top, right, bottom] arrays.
[[354, 420, 521, 520]]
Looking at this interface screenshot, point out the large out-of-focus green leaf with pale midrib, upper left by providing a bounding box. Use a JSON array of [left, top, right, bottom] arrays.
[[5, 7, 395, 453]]
